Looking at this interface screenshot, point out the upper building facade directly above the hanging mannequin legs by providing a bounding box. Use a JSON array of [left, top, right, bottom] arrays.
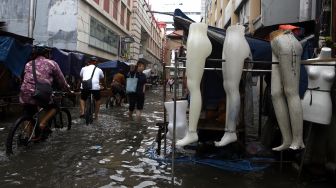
[[205, 0, 317, 33]]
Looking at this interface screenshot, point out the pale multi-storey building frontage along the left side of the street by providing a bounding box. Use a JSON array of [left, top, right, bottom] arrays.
[[0, 0, 161, 62]]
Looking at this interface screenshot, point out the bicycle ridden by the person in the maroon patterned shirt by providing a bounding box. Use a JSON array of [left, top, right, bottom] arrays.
[[6, 92, 71, 155]]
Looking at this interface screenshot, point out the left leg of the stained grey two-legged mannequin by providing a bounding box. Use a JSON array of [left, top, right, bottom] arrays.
[[271, 64, 292, 151]]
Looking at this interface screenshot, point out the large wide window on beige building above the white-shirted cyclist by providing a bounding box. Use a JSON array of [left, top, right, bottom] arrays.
[[89, 17, 119, 54]]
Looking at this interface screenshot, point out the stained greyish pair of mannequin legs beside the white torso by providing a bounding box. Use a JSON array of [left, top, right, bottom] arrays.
[[271, 30, 305, 151]]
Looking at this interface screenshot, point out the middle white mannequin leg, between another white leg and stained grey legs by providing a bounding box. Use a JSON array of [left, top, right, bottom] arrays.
[[215, 25, 250, 147]]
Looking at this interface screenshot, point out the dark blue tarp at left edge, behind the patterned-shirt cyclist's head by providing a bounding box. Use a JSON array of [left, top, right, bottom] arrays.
[[0, 36, 32, 77]]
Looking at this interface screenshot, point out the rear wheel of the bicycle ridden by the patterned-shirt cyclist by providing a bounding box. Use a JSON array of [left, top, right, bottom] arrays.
[[6, 116, 35, 155]]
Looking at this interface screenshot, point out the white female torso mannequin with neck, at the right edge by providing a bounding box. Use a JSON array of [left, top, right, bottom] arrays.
[[302, 47, 336, 125]]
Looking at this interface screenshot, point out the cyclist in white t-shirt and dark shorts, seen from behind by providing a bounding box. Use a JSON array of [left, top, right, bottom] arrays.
[[80, 57, 104, 119]]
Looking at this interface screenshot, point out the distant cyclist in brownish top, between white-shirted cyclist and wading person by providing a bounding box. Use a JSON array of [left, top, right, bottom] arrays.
[[111, 69, 126, 106]]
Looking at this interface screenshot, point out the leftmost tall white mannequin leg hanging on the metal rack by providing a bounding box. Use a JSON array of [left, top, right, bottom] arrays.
[[176, 23, 212, 146]]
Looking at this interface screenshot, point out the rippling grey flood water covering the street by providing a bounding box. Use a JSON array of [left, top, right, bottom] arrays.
[[0, 88, 333, 188]]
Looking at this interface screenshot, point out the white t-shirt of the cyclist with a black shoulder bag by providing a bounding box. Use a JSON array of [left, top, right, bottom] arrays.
[[80, 65, 104, 90]]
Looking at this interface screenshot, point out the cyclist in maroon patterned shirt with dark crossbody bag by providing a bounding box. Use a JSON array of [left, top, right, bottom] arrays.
[[19, 46, 71, 140]]
